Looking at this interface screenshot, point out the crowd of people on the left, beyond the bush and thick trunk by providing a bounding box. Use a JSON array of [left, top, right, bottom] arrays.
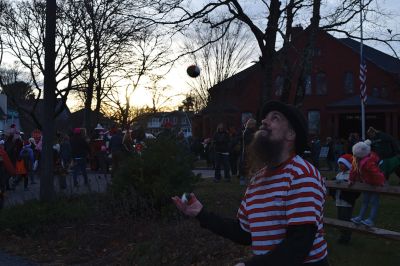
[[0, 124, 179, 200]]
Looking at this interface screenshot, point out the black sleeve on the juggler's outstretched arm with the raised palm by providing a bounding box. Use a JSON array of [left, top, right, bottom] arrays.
[[196, 209, 251, 245]]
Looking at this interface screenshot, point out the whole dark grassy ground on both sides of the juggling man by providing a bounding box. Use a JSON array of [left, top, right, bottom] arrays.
[[0, 173, 400, 266]]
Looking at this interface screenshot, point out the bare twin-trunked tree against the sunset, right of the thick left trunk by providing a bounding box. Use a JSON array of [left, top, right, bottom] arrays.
[[72, 0, 145, 128]]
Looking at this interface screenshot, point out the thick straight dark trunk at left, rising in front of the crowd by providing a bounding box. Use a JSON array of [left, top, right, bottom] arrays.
[[40, 0, 57, 202]]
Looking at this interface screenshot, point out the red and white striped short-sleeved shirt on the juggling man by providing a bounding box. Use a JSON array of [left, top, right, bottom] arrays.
[[237, 155, 327, 263]]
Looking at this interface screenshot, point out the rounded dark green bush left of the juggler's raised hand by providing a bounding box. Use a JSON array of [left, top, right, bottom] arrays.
[[111, 138, 197, 212]]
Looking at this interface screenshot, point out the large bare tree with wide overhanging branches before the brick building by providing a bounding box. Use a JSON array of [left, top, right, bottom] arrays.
[[132, 0, 399, 110]]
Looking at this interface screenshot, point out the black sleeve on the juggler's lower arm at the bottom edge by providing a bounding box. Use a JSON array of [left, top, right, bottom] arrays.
[[244, 224, 317, 266]]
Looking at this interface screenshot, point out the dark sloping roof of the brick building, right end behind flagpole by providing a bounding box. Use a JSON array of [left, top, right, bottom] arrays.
[[337, 38, 400, 73]]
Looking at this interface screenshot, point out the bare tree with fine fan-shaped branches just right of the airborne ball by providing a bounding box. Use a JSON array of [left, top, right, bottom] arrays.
[[184, 20, 255, 110]]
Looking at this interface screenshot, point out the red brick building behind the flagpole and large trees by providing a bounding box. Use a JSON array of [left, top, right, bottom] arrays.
[[193, 28, 400, 139]]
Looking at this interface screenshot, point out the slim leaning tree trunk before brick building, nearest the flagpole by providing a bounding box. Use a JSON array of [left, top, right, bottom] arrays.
[[294, 0, 321, 107]]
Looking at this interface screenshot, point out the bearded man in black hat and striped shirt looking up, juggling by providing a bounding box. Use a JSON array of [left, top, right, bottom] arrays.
[[172, 101, 328, 266]]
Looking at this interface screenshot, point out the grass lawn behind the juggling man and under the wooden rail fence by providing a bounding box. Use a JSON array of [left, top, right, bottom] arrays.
[[191, 173, 400, 266]]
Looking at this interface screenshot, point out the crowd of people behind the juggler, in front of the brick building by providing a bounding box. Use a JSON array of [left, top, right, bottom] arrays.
[[197, 115, 400, 188]]
